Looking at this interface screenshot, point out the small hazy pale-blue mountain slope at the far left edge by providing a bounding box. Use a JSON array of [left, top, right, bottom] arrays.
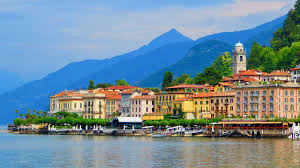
[[0, 69, 24, 94]]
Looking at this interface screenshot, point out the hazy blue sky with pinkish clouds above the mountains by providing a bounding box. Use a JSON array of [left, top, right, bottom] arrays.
[[0, 0, 295, 81]]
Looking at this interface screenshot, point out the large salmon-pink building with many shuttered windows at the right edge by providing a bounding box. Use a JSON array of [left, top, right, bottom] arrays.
[[235, 83, 300, 119]]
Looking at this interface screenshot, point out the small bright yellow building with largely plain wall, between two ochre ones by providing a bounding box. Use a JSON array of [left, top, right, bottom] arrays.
[[172, 96, 196, 119]]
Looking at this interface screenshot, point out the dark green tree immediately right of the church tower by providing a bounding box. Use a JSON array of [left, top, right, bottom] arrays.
[[247, 42, 263, 69]]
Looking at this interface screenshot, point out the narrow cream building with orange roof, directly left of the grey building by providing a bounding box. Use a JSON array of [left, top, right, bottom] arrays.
[[105, 94, 121, 118]]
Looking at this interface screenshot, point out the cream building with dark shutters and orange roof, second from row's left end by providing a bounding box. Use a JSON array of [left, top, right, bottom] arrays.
[[83, 91, 120, 118]]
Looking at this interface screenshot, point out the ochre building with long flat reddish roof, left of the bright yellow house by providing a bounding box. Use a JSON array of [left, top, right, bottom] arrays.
[[154, 92, 193, 114]]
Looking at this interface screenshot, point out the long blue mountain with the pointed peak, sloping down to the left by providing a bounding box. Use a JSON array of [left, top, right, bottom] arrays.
[[0, 29, 194, 123]]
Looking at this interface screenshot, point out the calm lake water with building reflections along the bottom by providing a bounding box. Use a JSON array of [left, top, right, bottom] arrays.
[[0, 133, 300, 168]]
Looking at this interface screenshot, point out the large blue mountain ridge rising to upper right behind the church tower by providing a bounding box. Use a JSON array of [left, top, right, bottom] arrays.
[[136, 15, 287, 87]]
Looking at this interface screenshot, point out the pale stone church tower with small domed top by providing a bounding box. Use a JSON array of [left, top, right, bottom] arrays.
[[232, 42, 246, 74]]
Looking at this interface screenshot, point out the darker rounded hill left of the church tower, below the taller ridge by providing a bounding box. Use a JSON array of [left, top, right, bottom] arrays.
[[136, 40, 233, 87]]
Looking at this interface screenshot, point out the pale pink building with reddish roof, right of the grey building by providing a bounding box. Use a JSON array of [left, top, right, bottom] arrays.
[[130, 95, 155, 118]]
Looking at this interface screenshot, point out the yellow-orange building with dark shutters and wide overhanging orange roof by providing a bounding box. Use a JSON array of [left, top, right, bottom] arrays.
[[192, 93, 214, 119]]
